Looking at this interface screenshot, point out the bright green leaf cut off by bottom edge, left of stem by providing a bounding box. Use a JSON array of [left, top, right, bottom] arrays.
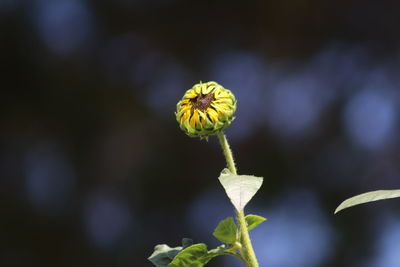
[[168, 244, 216, 267]]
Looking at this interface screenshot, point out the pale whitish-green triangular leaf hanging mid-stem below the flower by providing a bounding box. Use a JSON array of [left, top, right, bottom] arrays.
[[218, 169, 263, 211]]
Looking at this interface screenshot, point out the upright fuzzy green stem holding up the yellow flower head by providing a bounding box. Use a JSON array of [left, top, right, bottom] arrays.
[[217, 131, 258, 267]]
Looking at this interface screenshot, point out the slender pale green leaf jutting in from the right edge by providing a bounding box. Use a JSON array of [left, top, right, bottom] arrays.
[[335, 190, 400, 214]]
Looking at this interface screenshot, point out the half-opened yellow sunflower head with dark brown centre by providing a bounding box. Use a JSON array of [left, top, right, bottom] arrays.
[[175, 82, 236, 138]]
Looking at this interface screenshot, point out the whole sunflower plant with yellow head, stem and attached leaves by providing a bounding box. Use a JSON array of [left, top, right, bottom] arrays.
[[148, 82, 266, 267]]
